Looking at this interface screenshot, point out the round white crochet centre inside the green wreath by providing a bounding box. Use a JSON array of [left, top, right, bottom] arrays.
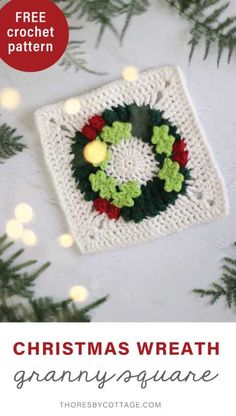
[[106, 137, 158, 185]]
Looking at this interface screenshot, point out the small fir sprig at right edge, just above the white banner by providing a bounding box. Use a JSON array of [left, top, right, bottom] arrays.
[[193, 243, 236, 309]]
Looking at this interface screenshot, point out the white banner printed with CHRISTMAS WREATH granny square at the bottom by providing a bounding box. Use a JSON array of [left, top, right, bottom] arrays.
[[0, 323, 236, 416]]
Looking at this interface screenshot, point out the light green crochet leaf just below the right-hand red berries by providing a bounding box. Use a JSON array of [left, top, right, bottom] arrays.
[[158, 158, 184, 192]]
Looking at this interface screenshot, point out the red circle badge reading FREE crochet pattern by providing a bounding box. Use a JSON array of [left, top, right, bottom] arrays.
[[0, 0, 69, 72]]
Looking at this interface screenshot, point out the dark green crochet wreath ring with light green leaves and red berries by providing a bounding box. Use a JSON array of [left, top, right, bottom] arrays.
[[71, 103, 190, 223]]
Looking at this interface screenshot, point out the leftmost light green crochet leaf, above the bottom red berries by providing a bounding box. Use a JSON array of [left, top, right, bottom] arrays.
[[89, 170, 117, 200]]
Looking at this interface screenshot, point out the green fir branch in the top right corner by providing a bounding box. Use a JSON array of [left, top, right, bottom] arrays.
[[164, 0, 236, 65]]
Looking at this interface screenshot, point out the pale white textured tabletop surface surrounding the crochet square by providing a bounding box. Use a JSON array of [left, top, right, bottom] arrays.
[[0, 0, 236, 321]]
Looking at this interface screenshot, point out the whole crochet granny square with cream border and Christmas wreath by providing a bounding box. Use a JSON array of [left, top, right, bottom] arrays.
[[36, 67, 228, 253]]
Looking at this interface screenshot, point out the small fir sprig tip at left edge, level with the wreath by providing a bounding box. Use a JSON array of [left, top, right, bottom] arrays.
[[0, 123, 26, 163]]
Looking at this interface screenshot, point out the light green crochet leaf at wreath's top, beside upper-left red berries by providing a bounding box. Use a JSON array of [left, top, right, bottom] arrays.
[[100, 121, 132, 144]]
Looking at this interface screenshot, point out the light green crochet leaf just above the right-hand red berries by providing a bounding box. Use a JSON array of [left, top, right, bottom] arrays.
[[151, 124, 175, 156]]
